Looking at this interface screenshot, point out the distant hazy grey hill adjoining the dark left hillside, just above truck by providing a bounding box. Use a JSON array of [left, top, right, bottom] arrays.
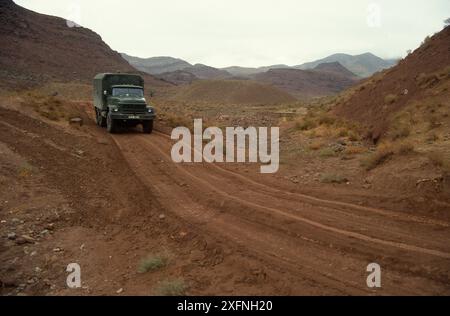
[[121, 53, 192, 75]]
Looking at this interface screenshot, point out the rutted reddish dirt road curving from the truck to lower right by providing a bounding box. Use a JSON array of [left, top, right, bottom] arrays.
[[114, 132, 450, 294]]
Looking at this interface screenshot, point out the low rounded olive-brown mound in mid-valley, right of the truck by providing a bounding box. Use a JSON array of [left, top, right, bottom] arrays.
[[168, 80, 296, 105]]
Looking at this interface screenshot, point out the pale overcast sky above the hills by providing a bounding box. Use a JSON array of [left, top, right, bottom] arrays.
[[15, 0, 450, 67]]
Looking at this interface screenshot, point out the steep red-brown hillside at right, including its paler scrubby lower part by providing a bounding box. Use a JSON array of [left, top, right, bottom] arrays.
[[334, 27, 450, 141]]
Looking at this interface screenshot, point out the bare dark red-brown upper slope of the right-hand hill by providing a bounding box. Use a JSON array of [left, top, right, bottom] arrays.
[[334, 27, 450, 140]]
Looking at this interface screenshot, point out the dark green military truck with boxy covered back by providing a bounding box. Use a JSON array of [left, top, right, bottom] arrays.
[[94, 73, 156, 134]]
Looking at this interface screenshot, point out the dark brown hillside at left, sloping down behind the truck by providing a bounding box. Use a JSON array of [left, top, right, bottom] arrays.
[[0, 0, 165, 88]]
